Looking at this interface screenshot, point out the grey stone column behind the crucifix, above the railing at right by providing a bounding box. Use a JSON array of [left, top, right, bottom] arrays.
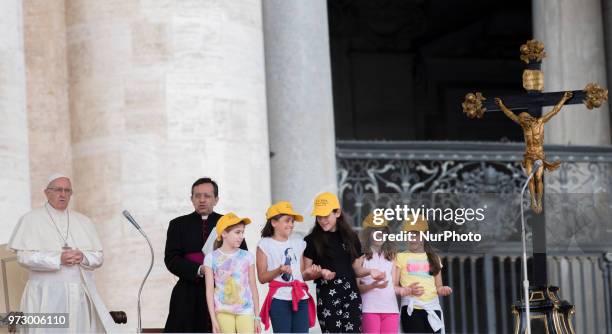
[[533, 0, 610, 145]]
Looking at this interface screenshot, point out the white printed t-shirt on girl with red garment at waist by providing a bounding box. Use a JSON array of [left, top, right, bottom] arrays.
[[257, 237, 308, 300]]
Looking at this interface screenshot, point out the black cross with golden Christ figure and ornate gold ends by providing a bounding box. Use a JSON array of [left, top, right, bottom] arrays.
[[461, 40, 608, 213]]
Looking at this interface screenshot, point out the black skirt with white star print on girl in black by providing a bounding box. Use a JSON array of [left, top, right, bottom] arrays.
[[317, 277, 361, 333]]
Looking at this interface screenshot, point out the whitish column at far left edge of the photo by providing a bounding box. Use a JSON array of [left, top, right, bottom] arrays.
[[0, 0, 31, 244]]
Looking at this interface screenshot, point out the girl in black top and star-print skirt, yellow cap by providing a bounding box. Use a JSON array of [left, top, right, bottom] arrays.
[[304, 193, 384, 333]]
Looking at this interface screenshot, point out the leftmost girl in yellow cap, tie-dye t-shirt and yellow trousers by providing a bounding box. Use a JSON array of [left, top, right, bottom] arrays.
[[204, 212, 261, 333]]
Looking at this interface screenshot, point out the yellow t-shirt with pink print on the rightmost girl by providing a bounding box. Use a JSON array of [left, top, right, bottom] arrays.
[[395, 252, 438, 302]]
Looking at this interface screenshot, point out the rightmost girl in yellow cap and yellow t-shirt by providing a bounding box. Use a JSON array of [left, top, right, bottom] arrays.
[[395, 216, 452, 333]]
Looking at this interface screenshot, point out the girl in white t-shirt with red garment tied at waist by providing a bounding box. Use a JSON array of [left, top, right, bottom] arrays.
[[256, 202, 320, 333]]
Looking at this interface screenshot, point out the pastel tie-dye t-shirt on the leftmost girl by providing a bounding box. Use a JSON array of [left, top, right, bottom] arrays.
[[204, 249, 255, 314]]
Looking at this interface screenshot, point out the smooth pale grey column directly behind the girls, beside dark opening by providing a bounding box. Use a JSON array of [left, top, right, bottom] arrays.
[[263, 0, 337, 233]]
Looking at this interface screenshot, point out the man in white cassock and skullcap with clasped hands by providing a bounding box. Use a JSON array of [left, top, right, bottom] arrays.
[[8, 174, 119, 333]]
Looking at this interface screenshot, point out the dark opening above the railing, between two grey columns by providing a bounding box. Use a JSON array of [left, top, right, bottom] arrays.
[[328, 0, 532, 141]]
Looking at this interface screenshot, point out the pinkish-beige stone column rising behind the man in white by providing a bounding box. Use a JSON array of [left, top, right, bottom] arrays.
[[23, 0, 72, 206]]
